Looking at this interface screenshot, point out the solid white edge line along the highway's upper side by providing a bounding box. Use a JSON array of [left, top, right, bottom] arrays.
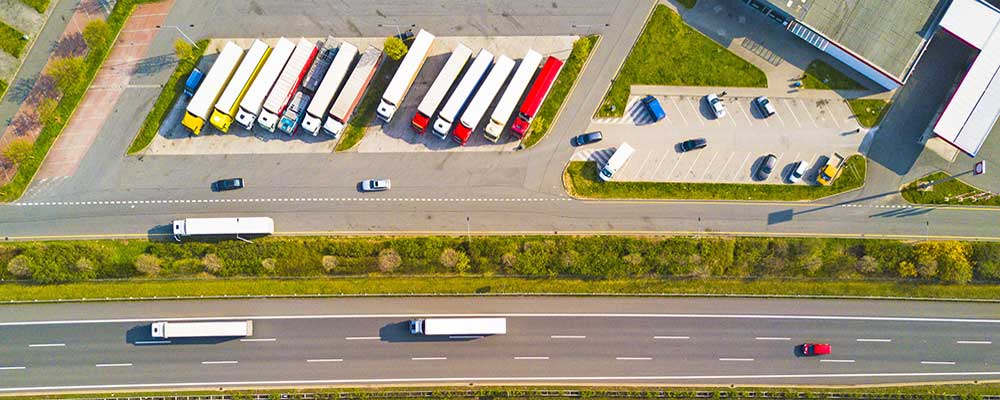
[[0, 313, 1000, 326]]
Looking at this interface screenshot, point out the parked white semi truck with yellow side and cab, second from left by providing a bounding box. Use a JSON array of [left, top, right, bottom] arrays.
[[209, 40, 271, 133]]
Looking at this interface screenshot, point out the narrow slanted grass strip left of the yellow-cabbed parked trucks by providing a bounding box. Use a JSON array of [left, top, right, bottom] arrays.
[[128, 39, 208, 154]]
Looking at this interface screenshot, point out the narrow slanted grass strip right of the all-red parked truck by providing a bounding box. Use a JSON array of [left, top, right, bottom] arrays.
[[521, 36, 597, 148]]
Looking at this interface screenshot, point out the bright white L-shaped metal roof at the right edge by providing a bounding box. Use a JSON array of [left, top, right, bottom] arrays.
[[934, 0, 1000, 156]]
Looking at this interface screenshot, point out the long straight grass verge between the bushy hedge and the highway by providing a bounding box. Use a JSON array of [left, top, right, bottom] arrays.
[[0, 276, 1000, 302]]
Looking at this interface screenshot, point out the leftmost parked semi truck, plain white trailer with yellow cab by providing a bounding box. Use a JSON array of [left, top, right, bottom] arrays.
[[181, 42, 243, 135]]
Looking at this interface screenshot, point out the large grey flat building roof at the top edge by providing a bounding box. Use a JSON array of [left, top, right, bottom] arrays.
[[771, 0, 940, 81]]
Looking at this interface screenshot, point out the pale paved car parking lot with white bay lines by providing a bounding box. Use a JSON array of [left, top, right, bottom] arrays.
[[573, 89, 867, 184]]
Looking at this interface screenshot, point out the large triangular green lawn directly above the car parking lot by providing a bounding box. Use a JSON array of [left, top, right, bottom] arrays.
[[597, 5, 767, 117]]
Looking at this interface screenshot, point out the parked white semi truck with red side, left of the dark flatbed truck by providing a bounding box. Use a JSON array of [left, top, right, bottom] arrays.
[[257, 38, 317, 132]]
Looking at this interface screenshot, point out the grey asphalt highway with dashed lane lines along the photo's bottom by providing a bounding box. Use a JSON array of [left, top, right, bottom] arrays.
[[0, 297, 1000, 392]]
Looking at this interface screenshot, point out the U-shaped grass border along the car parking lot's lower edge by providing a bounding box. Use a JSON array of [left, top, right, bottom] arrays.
[[563, 155, 866, 201]]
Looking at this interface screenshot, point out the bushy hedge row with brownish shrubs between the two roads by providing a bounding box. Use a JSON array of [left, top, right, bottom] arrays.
[[0, 236, 1000, 284]]
